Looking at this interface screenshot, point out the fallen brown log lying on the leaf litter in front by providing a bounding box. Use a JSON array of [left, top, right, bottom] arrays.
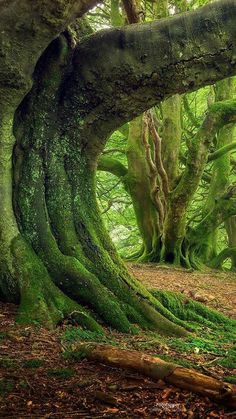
[[74, 343, 236, 408]]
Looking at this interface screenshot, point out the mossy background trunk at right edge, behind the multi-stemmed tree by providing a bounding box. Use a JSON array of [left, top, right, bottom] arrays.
[[188, 78, 235, 266]]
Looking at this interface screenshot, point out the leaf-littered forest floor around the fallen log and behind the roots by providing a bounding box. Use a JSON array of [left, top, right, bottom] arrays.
[[0, 264, 236, 419]]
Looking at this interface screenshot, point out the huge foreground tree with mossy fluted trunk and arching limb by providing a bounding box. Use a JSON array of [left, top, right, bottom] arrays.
[[0, 0, 236, 335]]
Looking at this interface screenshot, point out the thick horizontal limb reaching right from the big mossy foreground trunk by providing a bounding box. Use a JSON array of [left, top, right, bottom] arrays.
[[64, 0, 236, 142]]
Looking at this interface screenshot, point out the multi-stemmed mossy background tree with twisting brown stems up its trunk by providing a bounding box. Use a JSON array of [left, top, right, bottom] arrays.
[[98, 1, 236, 267]]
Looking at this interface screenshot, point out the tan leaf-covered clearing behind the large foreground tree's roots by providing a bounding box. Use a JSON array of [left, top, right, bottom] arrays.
[[128, 264, 236, 318]]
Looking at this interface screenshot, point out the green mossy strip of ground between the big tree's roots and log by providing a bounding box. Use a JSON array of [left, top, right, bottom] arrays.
[[62, 291, 236, 379]]
